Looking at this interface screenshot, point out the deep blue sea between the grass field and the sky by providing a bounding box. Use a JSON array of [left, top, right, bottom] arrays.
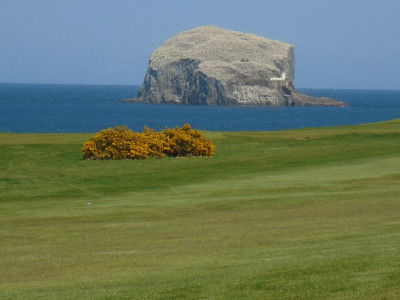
[[0, 84, 400, 132]]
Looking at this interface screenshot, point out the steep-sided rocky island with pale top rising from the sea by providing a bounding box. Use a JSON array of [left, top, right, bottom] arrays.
[[124, 26, 347, 106]]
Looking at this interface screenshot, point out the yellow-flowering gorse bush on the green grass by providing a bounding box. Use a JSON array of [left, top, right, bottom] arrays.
[[82, 124, 215, 159]]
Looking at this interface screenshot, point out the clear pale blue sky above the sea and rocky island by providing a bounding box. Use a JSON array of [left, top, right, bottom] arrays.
[[0, 0, 400, 90]]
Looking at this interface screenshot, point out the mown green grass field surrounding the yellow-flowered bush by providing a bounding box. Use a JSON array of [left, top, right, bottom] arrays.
[[0, 120, 400, 299]]
